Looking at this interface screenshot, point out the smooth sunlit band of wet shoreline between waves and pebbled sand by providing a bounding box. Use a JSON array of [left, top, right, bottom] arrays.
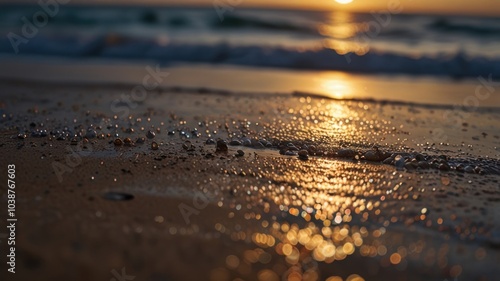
[[0, 57, 500, 108]]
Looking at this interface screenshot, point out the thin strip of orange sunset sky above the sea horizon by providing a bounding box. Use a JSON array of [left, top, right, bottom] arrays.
[[5, 0, 500, 17]]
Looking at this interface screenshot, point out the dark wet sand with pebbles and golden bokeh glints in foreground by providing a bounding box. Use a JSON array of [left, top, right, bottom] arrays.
[[0, 81, 500, 281]]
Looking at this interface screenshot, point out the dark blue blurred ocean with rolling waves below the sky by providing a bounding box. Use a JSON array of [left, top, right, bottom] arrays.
[[0, 5, 500, 78]]
